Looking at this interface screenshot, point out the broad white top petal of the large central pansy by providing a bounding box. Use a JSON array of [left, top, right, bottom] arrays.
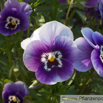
[[20, 21, 73, 49]]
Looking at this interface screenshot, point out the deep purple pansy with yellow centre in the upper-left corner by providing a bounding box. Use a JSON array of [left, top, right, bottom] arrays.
[[0, 0, 32, 36]]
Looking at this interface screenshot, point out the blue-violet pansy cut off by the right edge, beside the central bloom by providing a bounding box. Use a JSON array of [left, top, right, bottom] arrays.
[[74, 28, 103, 77]]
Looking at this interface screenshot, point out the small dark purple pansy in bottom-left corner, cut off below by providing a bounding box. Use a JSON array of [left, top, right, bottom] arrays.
[[2, 81, 29, 103]]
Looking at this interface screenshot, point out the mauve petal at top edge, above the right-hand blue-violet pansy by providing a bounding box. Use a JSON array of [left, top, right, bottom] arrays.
[[81, 0, 99, 8]]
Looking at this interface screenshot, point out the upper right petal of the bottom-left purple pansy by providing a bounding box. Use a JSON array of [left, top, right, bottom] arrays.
[[15, 81, 29, 97]]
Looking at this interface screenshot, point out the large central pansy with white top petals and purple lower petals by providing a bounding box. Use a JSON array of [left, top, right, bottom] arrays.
[[21, 21, 77, 85]]
